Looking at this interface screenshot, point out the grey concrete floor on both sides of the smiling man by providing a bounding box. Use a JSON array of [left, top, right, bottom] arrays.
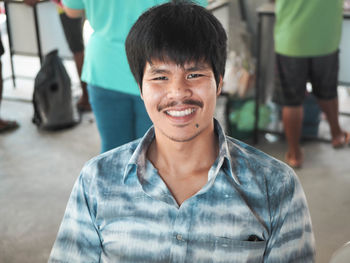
[[0, 21, 350, 263]]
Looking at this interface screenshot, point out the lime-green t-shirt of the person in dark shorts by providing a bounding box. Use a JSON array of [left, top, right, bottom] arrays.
[[274, 0, 343, 57]]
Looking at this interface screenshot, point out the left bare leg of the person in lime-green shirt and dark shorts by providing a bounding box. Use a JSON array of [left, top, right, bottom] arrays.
[[282, 106, 303, 168]]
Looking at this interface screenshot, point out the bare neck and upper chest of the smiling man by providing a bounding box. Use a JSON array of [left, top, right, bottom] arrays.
[[147, 127, 219, 206]]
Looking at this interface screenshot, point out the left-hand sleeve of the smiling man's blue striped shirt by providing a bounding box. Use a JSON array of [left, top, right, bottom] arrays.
[[48, 170, 102, 263]]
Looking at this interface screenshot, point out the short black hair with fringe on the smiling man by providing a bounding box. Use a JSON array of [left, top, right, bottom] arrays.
[[125, 1, 227, 88]]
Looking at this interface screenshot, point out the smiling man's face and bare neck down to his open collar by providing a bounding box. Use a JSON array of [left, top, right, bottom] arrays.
[[142, 59, 222, 204]]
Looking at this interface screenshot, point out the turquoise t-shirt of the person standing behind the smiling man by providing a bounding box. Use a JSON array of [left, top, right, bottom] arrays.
[[62, 0, 207, 95]]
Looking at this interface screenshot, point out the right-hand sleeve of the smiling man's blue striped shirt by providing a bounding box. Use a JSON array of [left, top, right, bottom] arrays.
[[264, 171, 315, 263]]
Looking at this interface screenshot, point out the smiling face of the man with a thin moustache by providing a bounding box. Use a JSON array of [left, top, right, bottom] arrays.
[[142, 60, 222, 142]]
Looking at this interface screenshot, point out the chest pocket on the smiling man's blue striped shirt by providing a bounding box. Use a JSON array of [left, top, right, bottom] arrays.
[[213, 237, 266, 263]]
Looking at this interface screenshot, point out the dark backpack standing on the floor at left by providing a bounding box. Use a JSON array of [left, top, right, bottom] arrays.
[[33, 50, 80, 130]]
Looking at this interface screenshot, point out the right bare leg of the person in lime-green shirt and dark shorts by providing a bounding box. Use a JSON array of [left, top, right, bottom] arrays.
[[318, 98, 344, 147]]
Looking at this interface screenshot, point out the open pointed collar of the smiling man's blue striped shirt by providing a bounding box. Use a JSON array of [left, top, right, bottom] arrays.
[[123, 119, 240, 184]]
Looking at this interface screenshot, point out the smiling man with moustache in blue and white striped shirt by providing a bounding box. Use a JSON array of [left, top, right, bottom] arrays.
[[49, 1, 314, 263]]
